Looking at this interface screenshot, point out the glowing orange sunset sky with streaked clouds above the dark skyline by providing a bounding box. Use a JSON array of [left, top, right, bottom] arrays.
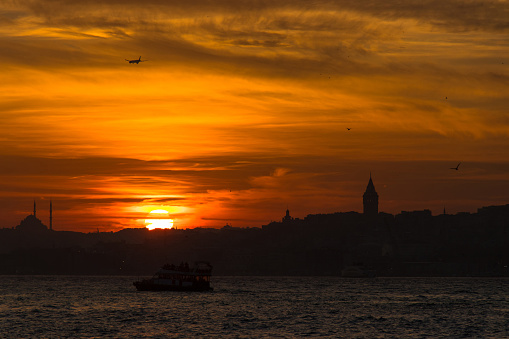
[[0, 0, 509, 232]]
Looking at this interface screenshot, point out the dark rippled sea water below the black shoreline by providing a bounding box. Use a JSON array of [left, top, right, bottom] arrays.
[[0, 276, 509, 338]]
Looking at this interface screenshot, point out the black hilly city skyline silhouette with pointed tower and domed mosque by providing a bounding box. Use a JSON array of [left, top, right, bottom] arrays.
[[0, 177, 509, 276]]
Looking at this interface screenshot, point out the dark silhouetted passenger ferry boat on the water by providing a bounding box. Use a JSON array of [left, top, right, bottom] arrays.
[[133, 261, 212, 291]]
